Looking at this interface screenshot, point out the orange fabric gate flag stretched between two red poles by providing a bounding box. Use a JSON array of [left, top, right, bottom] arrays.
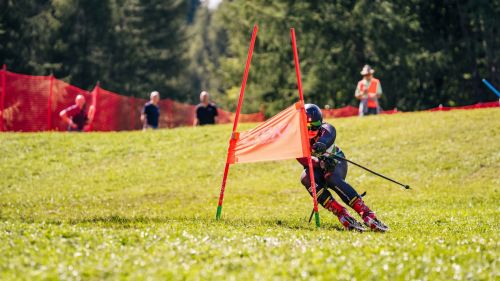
[[229, 102, 310, 164]]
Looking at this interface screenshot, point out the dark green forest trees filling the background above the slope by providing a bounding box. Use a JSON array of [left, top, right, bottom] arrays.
[[0, 0, 500, 114]]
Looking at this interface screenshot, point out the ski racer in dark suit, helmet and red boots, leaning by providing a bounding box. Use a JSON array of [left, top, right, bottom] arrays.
[[297, 104, 389, 232]]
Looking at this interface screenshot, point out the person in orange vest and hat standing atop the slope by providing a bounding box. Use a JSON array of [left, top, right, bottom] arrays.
[[354, 64, 382, 116]]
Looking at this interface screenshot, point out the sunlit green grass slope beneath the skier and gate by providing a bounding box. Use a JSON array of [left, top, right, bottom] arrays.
[[0, 109, 500, 280]]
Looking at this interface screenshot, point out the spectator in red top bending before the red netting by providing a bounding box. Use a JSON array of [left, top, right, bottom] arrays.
[[59, 95, 95, 132]]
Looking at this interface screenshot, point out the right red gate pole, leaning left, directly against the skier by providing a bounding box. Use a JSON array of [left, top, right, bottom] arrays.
[[290, 28, 320, 227]]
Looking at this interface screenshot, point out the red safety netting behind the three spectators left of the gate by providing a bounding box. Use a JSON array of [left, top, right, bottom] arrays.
[[0, 68, 265, 132]]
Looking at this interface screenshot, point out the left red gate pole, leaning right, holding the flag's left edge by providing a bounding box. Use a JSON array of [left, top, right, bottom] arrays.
[[215, 25, 259, 220]]
